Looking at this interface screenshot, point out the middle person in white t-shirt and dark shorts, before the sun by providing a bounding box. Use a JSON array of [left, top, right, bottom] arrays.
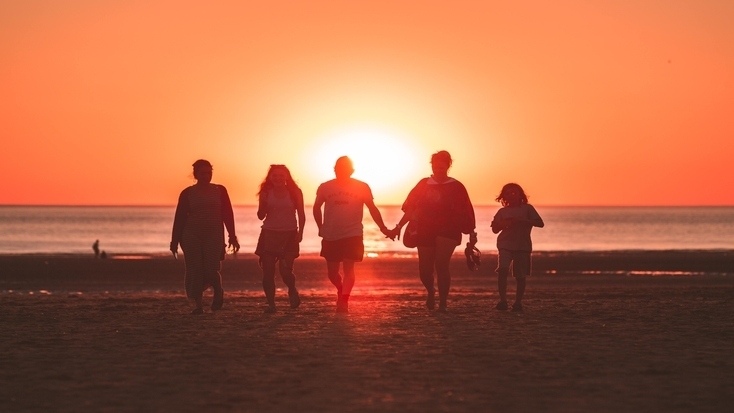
[[313, 156, 393, 313]]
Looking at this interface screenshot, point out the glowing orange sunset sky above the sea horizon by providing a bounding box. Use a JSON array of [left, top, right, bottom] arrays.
[[0, 0, 734, 205]]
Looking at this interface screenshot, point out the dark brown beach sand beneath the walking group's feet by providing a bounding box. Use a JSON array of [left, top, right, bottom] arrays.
[[0, 251, 734, 412]]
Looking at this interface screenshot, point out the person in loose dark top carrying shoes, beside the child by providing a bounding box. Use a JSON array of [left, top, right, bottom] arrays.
[[392, 151, 477, 311]]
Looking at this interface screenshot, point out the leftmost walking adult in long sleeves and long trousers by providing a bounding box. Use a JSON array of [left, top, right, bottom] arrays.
[[170, 159, 240, 314]]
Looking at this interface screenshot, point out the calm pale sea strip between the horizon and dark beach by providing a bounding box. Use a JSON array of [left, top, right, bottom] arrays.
[[0, 206, 734, 254]]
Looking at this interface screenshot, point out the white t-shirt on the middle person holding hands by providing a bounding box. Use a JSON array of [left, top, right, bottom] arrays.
[[316, 178, 372, 241]]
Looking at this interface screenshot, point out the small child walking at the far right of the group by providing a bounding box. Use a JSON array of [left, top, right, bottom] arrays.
[[491, 183, 545, 312]]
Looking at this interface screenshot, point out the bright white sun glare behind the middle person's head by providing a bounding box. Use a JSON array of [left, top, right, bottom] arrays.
[[309, 127, 423, 203]]
